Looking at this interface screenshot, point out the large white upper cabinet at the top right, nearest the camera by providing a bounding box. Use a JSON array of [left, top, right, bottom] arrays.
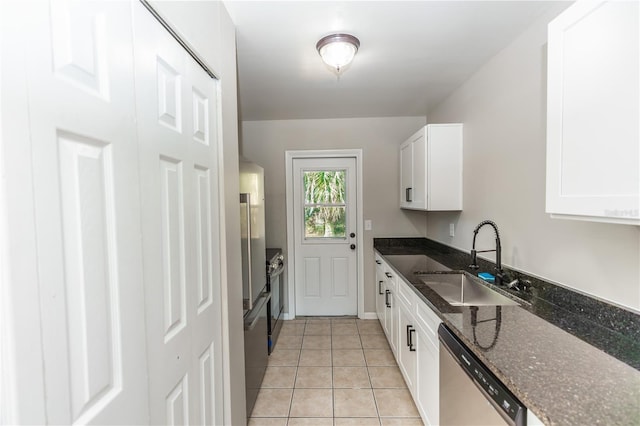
[[546, 1, 640, 225]]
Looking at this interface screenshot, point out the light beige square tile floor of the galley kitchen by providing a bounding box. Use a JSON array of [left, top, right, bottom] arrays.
[[249, 317, 422, 426]]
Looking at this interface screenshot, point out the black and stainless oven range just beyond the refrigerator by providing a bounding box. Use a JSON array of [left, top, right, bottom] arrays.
[[267, 248, 284, 353]]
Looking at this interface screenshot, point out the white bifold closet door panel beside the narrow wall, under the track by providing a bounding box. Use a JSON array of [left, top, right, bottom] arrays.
[[134, 3, 222, 424]]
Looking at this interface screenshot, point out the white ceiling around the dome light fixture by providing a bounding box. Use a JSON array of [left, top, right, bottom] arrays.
[[225, 1, 557, 121]]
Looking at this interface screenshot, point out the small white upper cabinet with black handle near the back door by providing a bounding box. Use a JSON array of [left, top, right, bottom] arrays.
[[400, 124, 462, 210]]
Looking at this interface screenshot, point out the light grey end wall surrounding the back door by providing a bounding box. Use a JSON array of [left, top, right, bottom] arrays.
[[241, 117, 426, 312]]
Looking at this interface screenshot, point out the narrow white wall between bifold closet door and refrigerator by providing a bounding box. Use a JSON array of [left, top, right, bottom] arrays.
[[153, 1, 246, 425]]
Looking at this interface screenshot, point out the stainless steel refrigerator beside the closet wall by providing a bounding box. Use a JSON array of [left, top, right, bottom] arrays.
[[240, 161, 271, 417]]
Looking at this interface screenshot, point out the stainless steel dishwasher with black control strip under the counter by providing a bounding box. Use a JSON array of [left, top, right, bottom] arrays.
[[438, 324, 527, 426]]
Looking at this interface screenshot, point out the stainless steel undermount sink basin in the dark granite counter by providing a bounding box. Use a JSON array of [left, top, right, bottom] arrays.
[[418, 274, 519, 306]]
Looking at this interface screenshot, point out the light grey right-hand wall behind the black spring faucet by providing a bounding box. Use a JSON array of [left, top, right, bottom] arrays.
[[426, 4, 640, 310]]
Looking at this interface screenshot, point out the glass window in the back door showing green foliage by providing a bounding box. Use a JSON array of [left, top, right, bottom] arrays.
[[303, 170, 347, 239]]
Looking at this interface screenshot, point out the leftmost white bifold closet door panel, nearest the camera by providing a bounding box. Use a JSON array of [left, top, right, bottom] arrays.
[[18, 0, 148, 424]]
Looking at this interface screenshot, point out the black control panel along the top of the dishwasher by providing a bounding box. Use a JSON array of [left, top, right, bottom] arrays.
[[438, 324, 526, 425]]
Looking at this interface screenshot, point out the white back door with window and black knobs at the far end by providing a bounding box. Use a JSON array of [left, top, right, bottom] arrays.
[[293, 157, 358, 315]]
